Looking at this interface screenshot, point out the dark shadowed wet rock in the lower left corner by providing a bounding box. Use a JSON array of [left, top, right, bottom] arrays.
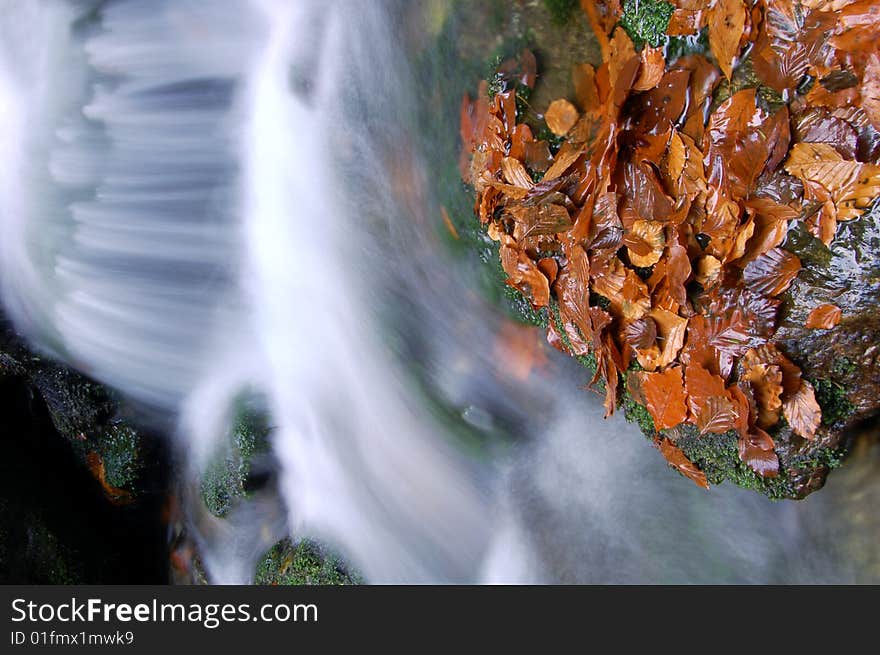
[[0, 317, 168, 584]]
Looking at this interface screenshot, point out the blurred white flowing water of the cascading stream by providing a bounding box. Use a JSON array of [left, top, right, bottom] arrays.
[[0, 0, 880, 582]]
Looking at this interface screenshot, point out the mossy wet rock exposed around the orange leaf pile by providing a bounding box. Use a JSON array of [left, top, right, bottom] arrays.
[[440, 0, 880, 498]]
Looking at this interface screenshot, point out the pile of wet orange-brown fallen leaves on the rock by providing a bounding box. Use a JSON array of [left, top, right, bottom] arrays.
[[461, 0, 880, 486]]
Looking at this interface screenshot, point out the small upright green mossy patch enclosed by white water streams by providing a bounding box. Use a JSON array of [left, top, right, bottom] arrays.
[[201, 401, 269, 517]]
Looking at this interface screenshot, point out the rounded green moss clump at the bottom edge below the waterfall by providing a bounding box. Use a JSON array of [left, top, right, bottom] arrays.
[[254, 539, 362, 585]]
